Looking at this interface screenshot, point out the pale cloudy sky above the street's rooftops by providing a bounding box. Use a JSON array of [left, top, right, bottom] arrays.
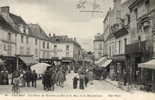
[[0, 0, 127, 50]]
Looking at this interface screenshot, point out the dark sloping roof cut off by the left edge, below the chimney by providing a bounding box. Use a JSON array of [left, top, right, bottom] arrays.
[[0, 15, 18, 33]]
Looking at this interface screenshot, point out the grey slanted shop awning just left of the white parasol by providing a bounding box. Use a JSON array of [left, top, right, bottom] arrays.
[[19, 56, 37, 66]]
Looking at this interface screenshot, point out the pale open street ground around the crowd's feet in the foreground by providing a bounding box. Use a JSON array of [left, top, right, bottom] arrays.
[[0, 72, 126, 94]]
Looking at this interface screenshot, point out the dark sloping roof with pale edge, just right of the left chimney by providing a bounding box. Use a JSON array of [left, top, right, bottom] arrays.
[[10, 13, 26, 25]]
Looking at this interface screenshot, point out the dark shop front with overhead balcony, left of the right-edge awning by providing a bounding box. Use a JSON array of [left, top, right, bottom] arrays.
[[126, 41, 151, 84]]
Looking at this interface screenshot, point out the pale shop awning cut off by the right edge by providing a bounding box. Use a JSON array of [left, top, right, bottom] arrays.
[[138, 59, 155, 69]]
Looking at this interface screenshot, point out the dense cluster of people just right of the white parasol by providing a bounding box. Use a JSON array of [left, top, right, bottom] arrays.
[[42, 66, 67, 91]]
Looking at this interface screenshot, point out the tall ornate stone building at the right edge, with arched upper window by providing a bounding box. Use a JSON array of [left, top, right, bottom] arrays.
[[126, 0, 155, 89]]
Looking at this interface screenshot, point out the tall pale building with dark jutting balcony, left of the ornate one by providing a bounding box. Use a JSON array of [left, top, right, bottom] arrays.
[[103, 0, 131, 80]]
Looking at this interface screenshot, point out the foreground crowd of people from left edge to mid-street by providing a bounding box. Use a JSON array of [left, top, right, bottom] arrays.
[[0, 62, 94, 91]]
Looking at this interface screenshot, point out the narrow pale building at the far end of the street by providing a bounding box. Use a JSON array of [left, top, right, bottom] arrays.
[[94, 33, 104, 60]]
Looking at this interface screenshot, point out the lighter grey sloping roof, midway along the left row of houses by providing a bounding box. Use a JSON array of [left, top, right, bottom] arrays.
[[29, 24, 49, 40]]
